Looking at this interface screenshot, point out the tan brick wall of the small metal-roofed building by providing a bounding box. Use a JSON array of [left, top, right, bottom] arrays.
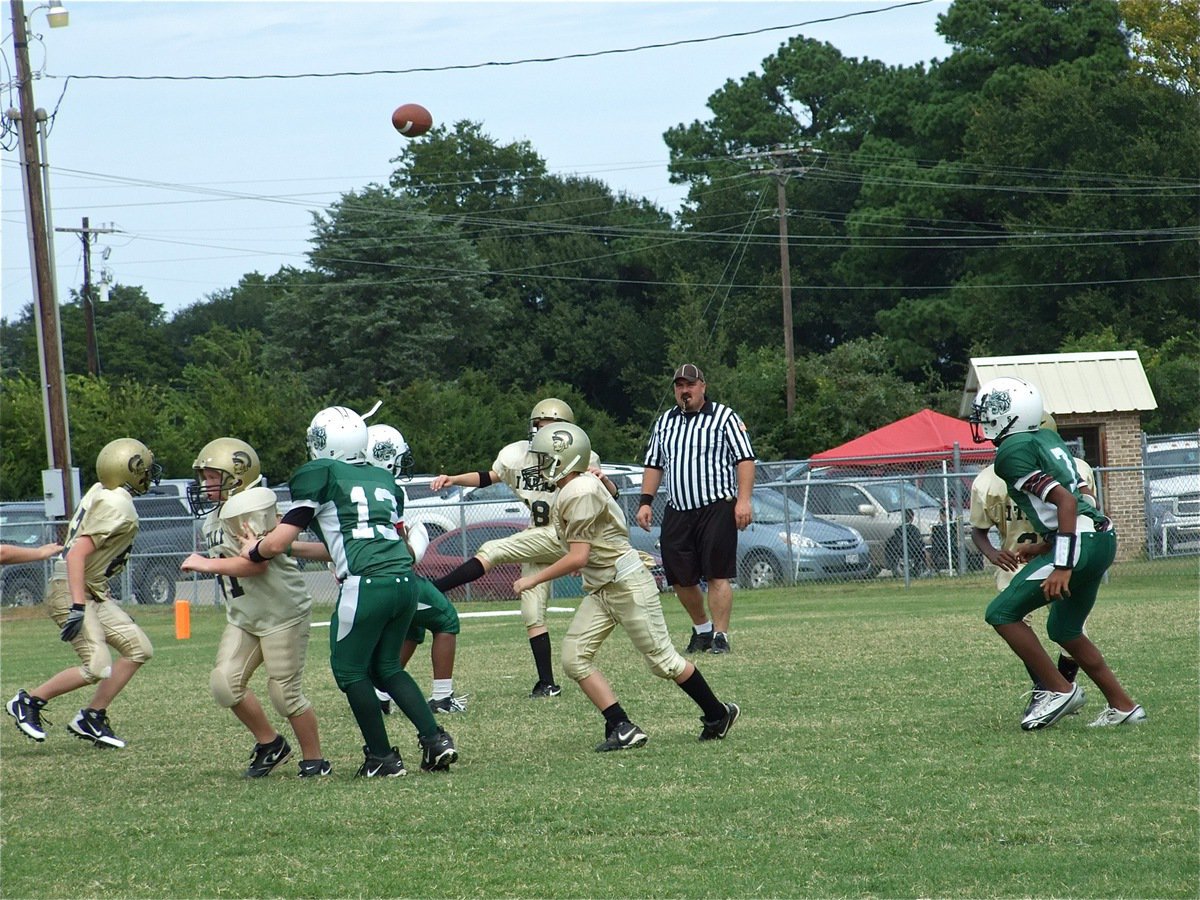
[[1055, 410, 1146, 560]]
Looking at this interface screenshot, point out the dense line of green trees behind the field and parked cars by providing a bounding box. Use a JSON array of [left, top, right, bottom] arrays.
[[0, 0, 1200, 499]]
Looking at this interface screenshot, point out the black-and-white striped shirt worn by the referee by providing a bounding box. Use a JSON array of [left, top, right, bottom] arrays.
[[646, 400, 755, 510]]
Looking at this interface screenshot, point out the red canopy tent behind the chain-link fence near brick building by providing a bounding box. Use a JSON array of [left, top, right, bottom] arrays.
[[810, 409, 996, 466]]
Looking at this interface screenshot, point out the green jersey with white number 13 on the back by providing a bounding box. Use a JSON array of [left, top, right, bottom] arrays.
[[288, 460, 413, 581]]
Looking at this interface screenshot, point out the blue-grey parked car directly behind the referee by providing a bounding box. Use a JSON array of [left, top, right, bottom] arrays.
[[620, 487, 874, 588]]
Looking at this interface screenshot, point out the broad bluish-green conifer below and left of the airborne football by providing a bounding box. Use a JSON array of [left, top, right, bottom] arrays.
[[266, 185, 498, 402]]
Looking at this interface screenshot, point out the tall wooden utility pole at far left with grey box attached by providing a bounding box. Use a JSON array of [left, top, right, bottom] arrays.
[[10, 0, 78, 517]]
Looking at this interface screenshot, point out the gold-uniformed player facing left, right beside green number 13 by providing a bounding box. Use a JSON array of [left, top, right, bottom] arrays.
[[180, 438, 332, 778]]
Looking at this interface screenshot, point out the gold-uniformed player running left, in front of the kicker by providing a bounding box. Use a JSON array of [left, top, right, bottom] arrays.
[[512, 422, 740, 752]]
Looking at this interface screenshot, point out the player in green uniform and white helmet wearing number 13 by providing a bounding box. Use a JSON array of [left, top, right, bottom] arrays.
[[242, 407, 458, 778]]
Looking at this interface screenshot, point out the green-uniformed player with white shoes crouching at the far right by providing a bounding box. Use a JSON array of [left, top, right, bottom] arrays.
[[970, 377, 1146, 731]]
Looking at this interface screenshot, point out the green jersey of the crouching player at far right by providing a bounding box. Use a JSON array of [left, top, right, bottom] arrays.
[[995, 428, 1104, 535]]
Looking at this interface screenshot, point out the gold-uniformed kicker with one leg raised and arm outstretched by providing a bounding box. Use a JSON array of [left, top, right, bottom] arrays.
[[430, 397, 617, 700]]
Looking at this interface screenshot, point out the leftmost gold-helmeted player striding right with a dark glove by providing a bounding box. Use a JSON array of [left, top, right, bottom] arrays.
[[6, 438, 162, 748]]
